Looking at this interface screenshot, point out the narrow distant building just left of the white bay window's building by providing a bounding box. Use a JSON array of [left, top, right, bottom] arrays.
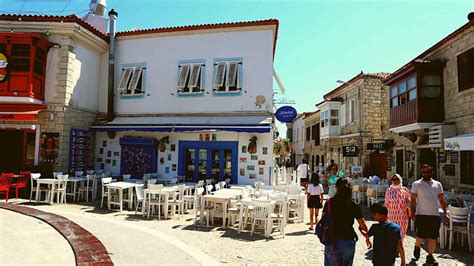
[[303, 110, 326, 170]]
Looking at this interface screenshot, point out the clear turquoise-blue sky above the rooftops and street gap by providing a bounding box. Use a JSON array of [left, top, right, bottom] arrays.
[[0, 0, 474, 136]]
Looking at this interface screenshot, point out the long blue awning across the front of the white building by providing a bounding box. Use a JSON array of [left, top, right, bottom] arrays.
[[92, 116, 272, 133]]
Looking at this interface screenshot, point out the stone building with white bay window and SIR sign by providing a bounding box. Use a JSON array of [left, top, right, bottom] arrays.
[[316, 72, 391, 177]]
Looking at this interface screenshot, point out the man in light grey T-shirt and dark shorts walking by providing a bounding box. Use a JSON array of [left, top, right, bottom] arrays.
[[410, 164, 449, 265]]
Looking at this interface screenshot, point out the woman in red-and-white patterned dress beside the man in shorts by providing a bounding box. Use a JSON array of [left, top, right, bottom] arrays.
[[385, 174, 410, 240]]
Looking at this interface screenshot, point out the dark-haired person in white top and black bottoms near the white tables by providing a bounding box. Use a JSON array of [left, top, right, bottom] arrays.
[[306, 173, 324, 230]]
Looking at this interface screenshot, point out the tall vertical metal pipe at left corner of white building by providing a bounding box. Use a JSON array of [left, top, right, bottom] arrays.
[[107, 8, 118, 122]]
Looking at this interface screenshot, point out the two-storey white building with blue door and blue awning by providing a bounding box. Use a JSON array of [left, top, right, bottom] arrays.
[[93, 20, 278, 184]]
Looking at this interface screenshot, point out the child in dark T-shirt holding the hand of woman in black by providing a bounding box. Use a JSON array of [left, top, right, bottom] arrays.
[[366, 203, 405, 266]]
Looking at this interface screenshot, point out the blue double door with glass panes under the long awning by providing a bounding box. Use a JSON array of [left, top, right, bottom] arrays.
[[178, 141, 238, 183]]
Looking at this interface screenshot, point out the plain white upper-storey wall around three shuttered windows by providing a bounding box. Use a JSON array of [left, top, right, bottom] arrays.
[[99, 30, 273, 114]]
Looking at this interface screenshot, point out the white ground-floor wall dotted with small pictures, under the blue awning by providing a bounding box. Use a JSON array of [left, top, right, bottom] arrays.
[[95, 131, 273, 184]]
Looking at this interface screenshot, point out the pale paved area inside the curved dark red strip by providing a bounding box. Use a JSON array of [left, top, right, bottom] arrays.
[[0, 209, 76, 265]]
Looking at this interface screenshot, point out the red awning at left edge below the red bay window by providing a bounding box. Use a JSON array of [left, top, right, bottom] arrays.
[[0, 103, 48, 121]]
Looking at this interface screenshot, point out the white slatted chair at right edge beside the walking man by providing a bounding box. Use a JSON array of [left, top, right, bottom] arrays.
[[445, 205, 472, 251]]
